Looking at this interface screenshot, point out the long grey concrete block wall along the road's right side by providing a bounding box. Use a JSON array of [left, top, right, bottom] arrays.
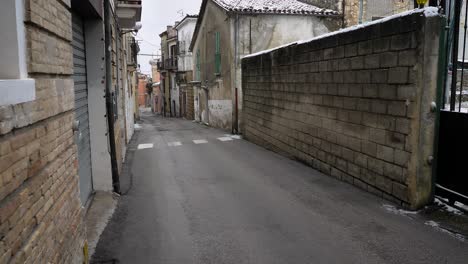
[[242, 11, 440, 208]]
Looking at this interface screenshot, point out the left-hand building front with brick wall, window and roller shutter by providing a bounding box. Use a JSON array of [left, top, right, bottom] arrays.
[[0, 0, 141, 263]]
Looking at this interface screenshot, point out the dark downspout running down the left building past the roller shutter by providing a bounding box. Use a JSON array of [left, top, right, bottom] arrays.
[[104, 0, 120, 193]]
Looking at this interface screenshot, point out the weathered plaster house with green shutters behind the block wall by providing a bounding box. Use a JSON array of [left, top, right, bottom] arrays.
[[190, 0, 342, 132]]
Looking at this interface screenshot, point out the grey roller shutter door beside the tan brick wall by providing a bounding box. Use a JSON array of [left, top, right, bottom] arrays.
[[72, 14, 93, 205]]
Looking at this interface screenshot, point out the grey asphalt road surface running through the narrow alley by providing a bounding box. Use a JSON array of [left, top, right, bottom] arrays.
[[92, 112, 468, 264]]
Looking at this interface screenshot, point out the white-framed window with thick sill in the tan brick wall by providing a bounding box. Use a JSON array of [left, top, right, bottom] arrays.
[[0, 0, 35, 106]]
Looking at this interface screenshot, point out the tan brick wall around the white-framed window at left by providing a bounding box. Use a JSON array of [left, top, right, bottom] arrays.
[[0, 0, 84, 263]]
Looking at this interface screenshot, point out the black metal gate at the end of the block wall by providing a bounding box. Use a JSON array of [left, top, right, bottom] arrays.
[[436, 0, 468, 204]]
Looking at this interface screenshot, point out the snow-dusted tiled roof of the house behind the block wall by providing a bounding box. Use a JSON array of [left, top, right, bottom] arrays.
[[213, 0, 339, 16]]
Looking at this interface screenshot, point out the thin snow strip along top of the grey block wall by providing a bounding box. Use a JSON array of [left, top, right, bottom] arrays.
[[242, 7, 439, 59]]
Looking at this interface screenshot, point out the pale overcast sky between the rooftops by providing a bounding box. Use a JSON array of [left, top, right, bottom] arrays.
[[136, 0, 201, 74]]
